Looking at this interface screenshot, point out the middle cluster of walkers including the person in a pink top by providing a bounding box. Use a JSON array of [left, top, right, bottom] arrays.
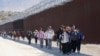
[[27, 26, 55, 49]]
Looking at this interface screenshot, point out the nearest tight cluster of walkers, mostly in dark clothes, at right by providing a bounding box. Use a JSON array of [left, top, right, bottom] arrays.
[[56, 25, 84, 55]]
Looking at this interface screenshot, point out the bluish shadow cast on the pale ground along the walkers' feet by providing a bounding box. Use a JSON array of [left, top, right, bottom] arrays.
[[7, 38, 92, 56]]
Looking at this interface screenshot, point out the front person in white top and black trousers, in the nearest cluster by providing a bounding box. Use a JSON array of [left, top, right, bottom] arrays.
[[60, 27, 70, 55]]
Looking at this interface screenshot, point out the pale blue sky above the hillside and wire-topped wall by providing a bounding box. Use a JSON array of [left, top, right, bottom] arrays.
[[0, 0, 42, 12]]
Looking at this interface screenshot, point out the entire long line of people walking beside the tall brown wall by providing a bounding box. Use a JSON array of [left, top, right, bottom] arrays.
[[0, 25, 84, 55]]
